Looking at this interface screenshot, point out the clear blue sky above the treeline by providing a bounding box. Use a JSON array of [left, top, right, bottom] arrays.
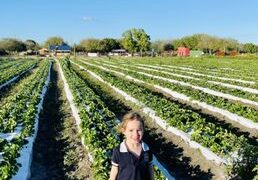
[[0, 0, 258, 45]]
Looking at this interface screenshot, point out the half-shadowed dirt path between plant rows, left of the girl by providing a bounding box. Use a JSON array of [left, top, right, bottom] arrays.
[[30, 64, 91, 180]]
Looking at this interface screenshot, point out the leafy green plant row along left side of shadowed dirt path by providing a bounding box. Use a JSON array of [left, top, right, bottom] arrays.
[[0, 61, 51, 179]]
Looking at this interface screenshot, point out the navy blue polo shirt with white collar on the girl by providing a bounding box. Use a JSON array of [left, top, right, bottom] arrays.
[[112, 141, 153, 180]]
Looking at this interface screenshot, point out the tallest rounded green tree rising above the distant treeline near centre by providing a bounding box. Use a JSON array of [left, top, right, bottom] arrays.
[[122, 28, 151, 54]]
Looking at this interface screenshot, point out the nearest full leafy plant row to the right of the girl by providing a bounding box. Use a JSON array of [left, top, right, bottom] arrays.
[[76, 60, 258, 177]]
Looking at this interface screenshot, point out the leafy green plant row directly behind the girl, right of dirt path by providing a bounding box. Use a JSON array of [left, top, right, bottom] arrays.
[[61, 61, 167, 179]]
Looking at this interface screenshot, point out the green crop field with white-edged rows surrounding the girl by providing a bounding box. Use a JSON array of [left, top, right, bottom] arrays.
[[0, 57, 258, 179]]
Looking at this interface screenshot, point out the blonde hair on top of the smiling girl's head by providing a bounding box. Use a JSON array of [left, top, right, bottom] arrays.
[[118, 112, 144, 133]]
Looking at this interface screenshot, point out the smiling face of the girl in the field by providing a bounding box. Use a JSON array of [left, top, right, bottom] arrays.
[[123, 120, 143, 144]]
